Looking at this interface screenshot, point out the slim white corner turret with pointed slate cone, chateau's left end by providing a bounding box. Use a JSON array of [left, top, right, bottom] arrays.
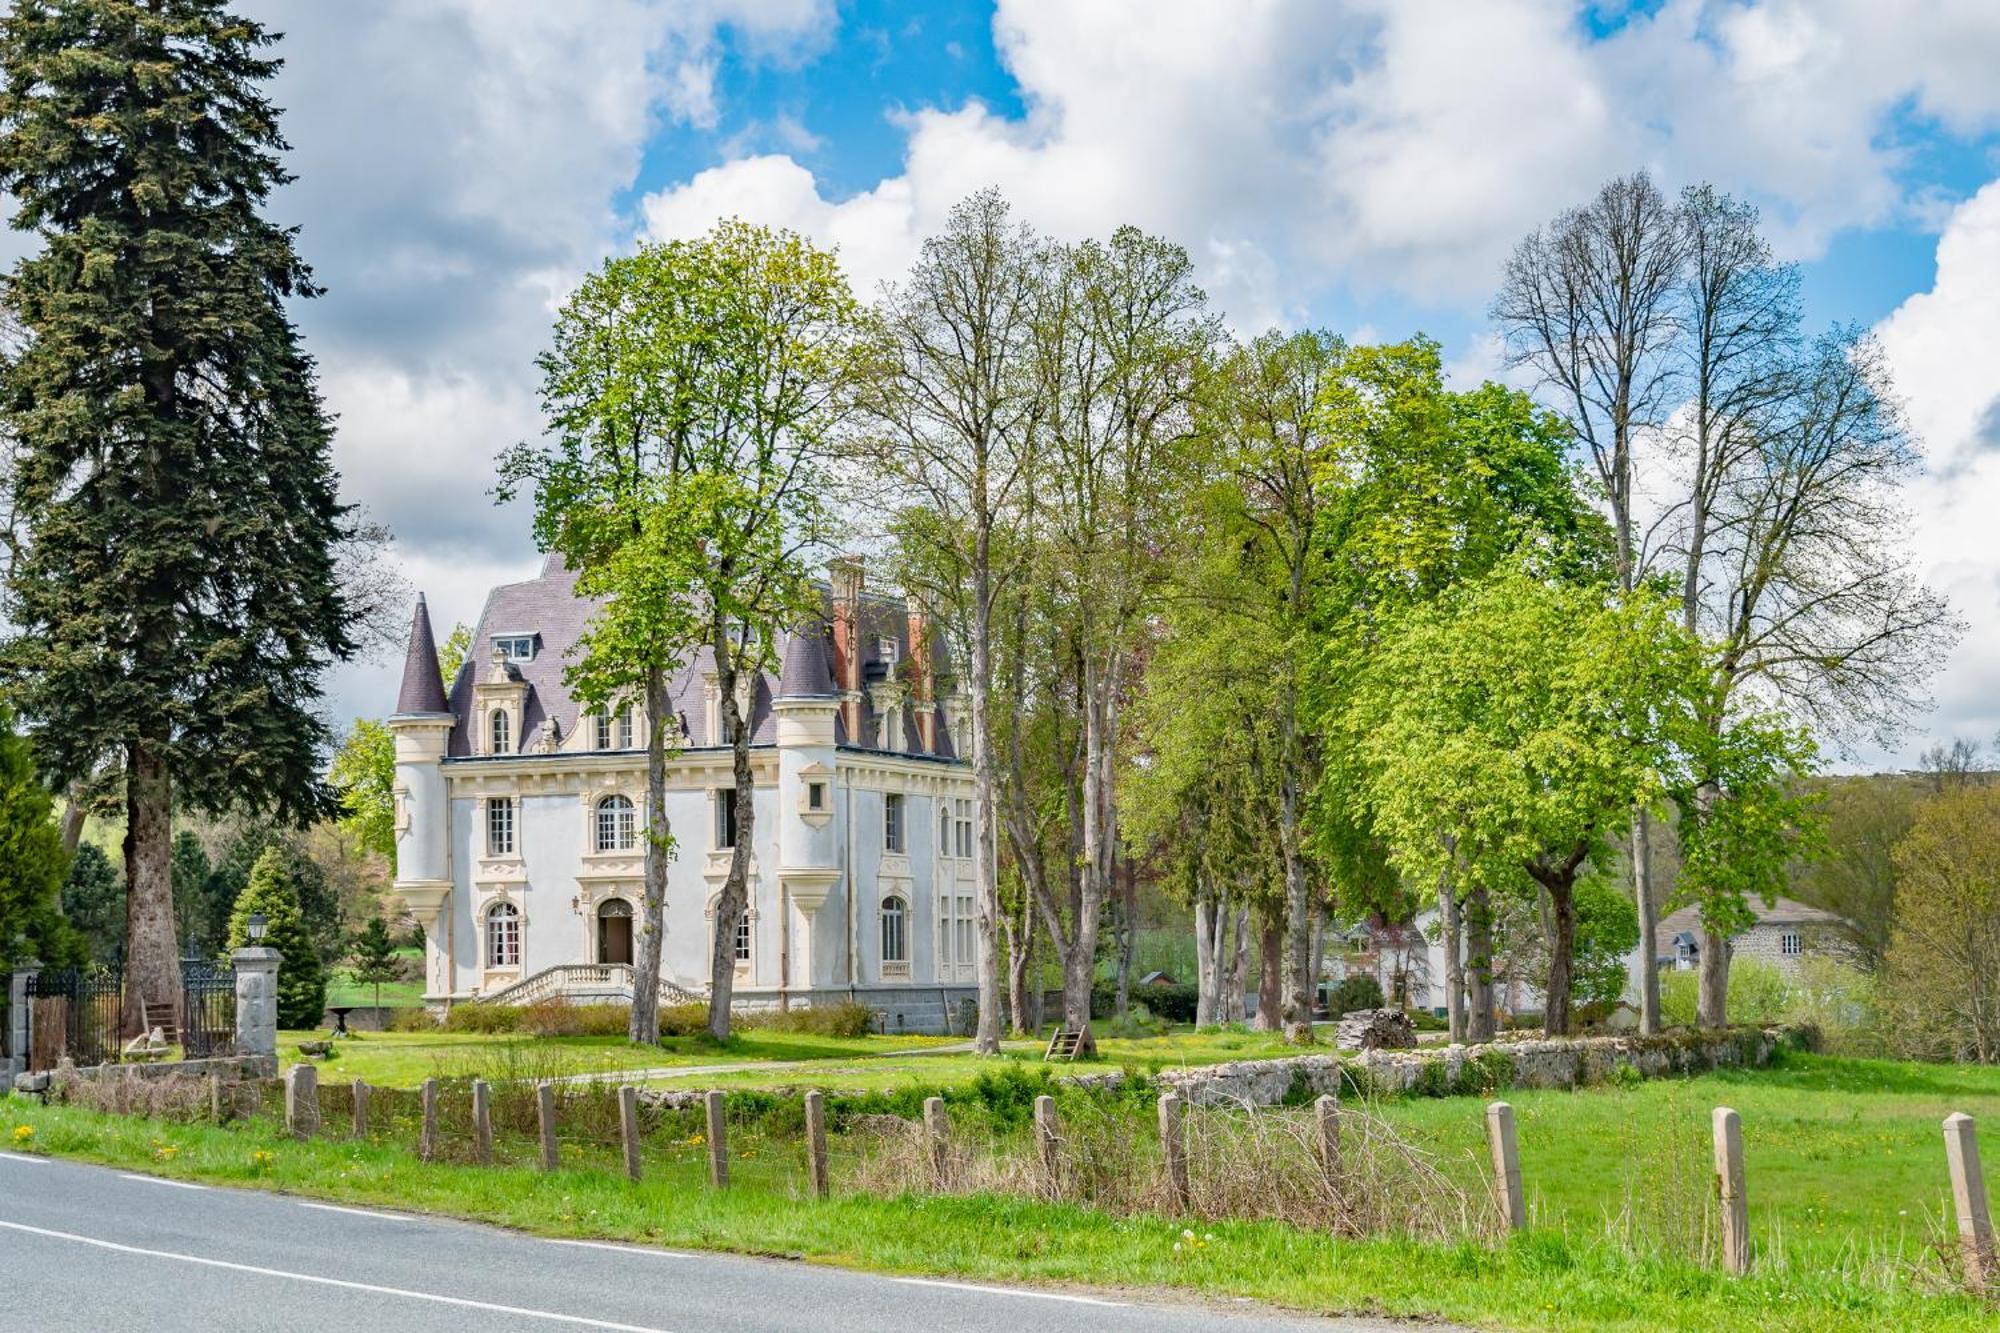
[[388, 594, 454, 995]]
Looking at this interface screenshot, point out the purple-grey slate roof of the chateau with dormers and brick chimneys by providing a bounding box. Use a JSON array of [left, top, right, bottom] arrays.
[[440, 556, 958, 759]]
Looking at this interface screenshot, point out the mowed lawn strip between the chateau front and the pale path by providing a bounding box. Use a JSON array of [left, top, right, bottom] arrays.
[[278, 1029, 954, 1087]]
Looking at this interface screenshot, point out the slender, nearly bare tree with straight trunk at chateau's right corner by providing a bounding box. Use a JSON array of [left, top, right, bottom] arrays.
[[864, 190, 1038, 1055]]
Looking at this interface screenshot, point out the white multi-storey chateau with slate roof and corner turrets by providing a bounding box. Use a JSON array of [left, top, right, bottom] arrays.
[[388, 558, 976, 1031]]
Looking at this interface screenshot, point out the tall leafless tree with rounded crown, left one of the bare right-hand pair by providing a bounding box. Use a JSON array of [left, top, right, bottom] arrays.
[[1492, 172, 1688, 1033]]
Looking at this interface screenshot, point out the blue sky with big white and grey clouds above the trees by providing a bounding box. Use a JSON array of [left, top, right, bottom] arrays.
[[203, 0, 2000, 767]]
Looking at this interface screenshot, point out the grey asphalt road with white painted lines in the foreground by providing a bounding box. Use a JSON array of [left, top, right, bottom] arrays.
[[0, 1153, 1434, 1333]]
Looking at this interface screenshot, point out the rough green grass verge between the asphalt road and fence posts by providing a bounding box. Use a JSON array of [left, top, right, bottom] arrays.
[[0, 1081, 1994, 1333]]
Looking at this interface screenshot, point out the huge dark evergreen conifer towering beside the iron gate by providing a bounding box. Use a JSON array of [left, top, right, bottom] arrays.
[[0, 0, 354, 1011]]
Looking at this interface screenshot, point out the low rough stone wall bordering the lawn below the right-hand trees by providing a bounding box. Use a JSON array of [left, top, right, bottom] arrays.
[[1158, 1027, 1816, 1107]]
